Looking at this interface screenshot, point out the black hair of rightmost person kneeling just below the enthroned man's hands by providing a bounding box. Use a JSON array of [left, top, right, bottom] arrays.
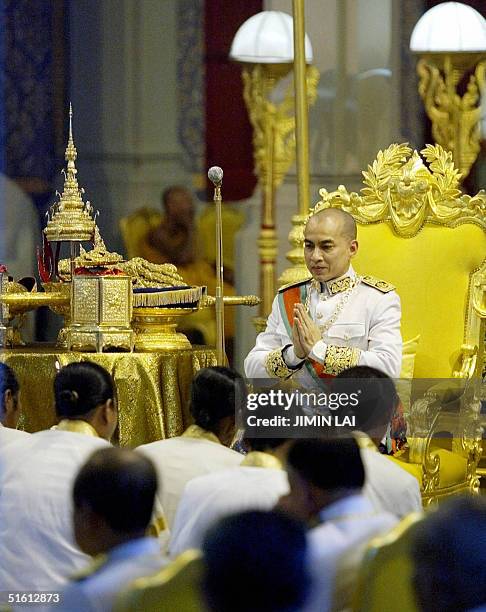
[[331, 366, 400, 434]]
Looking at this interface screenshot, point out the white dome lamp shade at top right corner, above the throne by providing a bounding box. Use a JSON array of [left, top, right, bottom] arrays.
[[410, 2, 486, 53]]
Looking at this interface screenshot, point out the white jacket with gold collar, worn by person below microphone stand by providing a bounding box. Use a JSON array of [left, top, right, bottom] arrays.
[[138, 425, 243, 529]]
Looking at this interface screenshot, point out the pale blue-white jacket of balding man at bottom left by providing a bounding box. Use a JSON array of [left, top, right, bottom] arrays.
[[53, 537, 168, 612]]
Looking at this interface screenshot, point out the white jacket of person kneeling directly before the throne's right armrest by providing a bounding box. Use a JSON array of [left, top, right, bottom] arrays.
[[358, 432, 423, 518]]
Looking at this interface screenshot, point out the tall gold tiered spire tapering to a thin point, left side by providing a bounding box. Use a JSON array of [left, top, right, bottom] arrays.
[[44, 103, 95, 242]]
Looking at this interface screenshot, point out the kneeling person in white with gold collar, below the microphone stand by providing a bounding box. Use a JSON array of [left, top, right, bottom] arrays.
[[139, 366, 246, 529]]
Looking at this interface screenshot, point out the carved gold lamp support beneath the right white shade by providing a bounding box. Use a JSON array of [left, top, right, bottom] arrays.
[[417, 53, 486, 178]]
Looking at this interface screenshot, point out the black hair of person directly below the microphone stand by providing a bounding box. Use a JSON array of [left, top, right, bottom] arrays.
[[190, 366, 246, 435]]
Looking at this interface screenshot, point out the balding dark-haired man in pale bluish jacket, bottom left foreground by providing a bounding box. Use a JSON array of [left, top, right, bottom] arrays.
[[52, 448, 167, 612]]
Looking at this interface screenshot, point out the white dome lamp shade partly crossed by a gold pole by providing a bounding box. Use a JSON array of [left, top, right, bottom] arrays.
[[230, 11, 313, 64]]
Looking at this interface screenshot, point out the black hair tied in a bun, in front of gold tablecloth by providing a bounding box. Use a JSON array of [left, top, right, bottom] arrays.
[[54, 361, 115, 419]]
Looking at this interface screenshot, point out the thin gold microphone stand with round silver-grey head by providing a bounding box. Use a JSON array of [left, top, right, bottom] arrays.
[[208, 166, 226, 366]]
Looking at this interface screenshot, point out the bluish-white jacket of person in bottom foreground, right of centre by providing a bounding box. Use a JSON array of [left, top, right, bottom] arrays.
[[303, 494, 398, 612]]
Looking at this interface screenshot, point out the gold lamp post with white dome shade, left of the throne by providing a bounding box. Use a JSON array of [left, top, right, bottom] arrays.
[[230, 11, 319, 331]]
